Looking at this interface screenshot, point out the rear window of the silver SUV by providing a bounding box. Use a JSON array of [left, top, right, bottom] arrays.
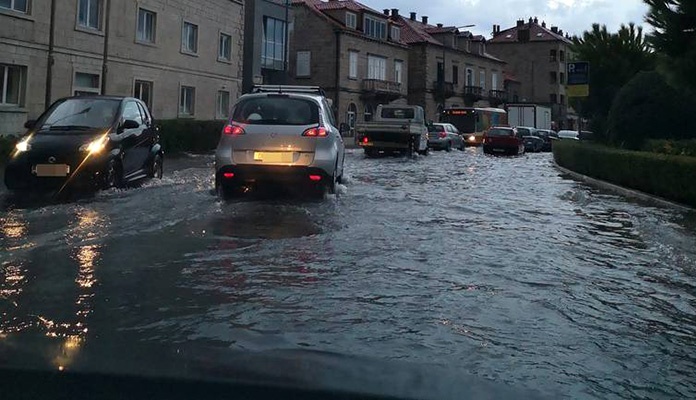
[[232, 96, 319, 125]]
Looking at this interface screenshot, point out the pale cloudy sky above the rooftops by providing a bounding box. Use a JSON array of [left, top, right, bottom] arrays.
[[358, 0, 649, 37]]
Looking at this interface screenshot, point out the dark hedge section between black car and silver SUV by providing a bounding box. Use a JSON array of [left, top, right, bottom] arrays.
[[156, 119, 225, 154]]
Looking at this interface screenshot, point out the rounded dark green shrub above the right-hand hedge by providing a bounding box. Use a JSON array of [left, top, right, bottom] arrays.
[[607, 71, 694, 149]]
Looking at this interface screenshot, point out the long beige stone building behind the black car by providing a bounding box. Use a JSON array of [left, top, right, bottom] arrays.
[[0, 0, 244, 134]]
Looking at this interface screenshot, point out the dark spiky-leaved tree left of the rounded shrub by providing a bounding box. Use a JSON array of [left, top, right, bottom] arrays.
[[572, 23, 655, 139]]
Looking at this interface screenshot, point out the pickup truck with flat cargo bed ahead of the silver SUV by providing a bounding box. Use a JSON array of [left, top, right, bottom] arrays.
[[355, 105, 428, 157]]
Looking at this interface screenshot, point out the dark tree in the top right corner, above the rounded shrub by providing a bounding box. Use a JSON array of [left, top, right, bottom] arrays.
[[644, 0, 696, 94]]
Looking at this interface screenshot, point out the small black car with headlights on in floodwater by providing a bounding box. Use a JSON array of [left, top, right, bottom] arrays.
[[5, 96, 164, 191]]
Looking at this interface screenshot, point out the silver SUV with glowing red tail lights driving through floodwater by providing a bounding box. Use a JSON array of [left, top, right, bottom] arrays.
[[215, 85, 347, 198]]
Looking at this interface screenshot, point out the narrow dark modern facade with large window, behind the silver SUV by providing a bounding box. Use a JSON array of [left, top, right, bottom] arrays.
[[242, 0, 292, 93]]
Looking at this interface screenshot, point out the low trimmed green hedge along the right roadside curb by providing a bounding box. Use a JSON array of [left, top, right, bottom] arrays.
[[553, 141, 696, 207]]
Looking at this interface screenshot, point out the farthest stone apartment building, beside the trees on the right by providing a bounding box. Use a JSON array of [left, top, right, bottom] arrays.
[[488, 18, 576, 129]]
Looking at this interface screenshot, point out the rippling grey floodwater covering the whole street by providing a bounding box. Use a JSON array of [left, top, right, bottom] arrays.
[[0, 148, 696, 399]]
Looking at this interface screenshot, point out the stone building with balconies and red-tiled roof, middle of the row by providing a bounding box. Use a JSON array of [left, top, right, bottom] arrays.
[[392, 12, 508, 121]]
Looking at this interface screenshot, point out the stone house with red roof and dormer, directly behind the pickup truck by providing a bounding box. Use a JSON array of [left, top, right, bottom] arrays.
[[290, 0, 410, 135]]
